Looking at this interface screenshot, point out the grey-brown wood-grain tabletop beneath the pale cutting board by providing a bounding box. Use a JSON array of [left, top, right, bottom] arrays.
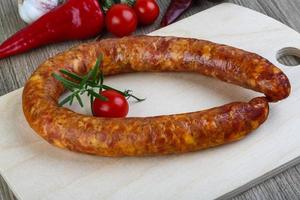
[[0, 0, 300, 200]]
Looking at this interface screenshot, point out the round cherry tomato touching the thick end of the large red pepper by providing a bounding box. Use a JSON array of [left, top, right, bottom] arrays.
[[105, 4, 137, 37]]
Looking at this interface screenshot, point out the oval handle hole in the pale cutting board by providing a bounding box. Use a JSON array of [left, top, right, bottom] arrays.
[[276, 47, 300, 67]]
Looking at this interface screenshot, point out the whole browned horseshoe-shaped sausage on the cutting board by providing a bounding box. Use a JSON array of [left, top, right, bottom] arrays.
[[23, 36, 290, 156]]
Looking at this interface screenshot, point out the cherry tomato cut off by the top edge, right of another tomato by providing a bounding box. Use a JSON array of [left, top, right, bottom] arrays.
[[134, 0, 159, 25]]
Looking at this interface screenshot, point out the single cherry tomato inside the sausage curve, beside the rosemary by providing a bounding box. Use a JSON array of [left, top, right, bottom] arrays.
[[93, 90, 129, 118]]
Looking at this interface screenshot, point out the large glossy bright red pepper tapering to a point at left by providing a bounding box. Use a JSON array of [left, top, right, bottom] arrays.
[[0, 0, 104, 59]]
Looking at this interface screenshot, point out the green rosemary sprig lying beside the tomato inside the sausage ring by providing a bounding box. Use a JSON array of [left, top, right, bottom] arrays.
[[52, 55, 145, 108]]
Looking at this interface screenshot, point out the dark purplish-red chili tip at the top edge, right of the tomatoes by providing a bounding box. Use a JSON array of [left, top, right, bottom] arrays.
[[160, 0, 192, 27]]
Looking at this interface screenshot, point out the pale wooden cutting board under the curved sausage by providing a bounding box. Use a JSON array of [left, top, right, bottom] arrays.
[[0, 4, 300, 200]]
